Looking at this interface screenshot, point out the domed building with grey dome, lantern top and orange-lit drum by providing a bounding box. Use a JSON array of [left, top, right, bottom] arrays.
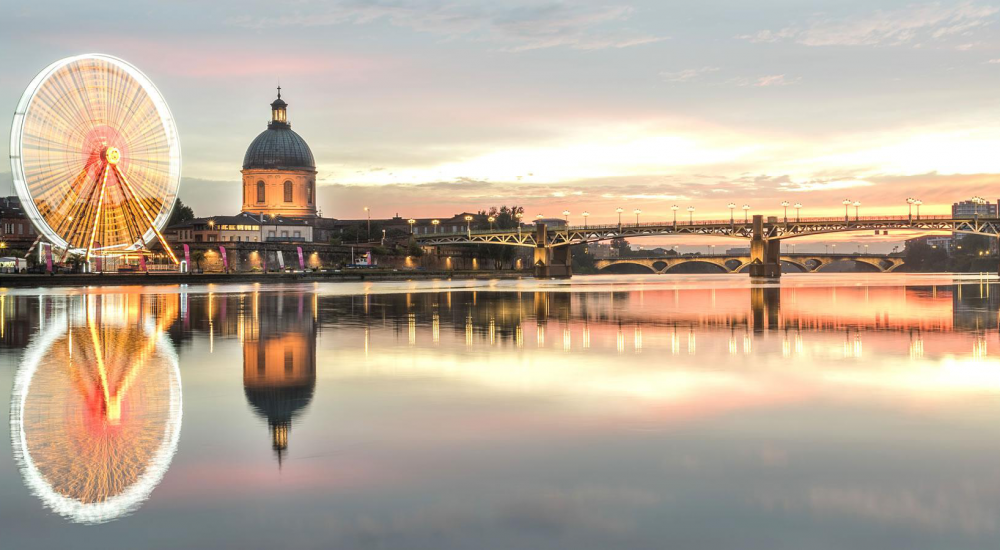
[[241, 86, 316, 218]]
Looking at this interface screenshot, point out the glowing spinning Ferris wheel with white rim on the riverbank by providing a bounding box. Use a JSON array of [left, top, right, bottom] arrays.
[[10, 54, 181, 263]]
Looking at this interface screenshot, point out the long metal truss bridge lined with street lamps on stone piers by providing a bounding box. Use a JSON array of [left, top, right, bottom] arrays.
[[412, 214, 1000, 278]]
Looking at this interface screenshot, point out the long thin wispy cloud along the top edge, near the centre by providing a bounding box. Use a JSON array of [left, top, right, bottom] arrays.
[[225, 0, 666, 52]]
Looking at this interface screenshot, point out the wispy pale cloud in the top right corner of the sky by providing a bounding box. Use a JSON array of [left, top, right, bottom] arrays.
[[737, 2, 1000, 46]]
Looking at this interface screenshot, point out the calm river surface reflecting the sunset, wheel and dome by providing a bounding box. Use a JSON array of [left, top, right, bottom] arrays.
[[0, 274, 1000, 549]]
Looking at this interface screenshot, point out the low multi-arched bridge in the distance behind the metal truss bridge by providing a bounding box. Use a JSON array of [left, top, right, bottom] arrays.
[[595, 253, 903, 273]]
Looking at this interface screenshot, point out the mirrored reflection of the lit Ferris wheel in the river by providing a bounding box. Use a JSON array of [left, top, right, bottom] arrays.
[[11, 294, 182, 524]]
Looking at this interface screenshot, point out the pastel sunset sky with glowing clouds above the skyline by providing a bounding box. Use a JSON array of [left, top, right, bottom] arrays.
[[0, 0, 1000, 252]]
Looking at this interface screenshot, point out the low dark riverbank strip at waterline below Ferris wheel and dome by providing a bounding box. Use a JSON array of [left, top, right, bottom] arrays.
[[0, 269, 532, 288]]
